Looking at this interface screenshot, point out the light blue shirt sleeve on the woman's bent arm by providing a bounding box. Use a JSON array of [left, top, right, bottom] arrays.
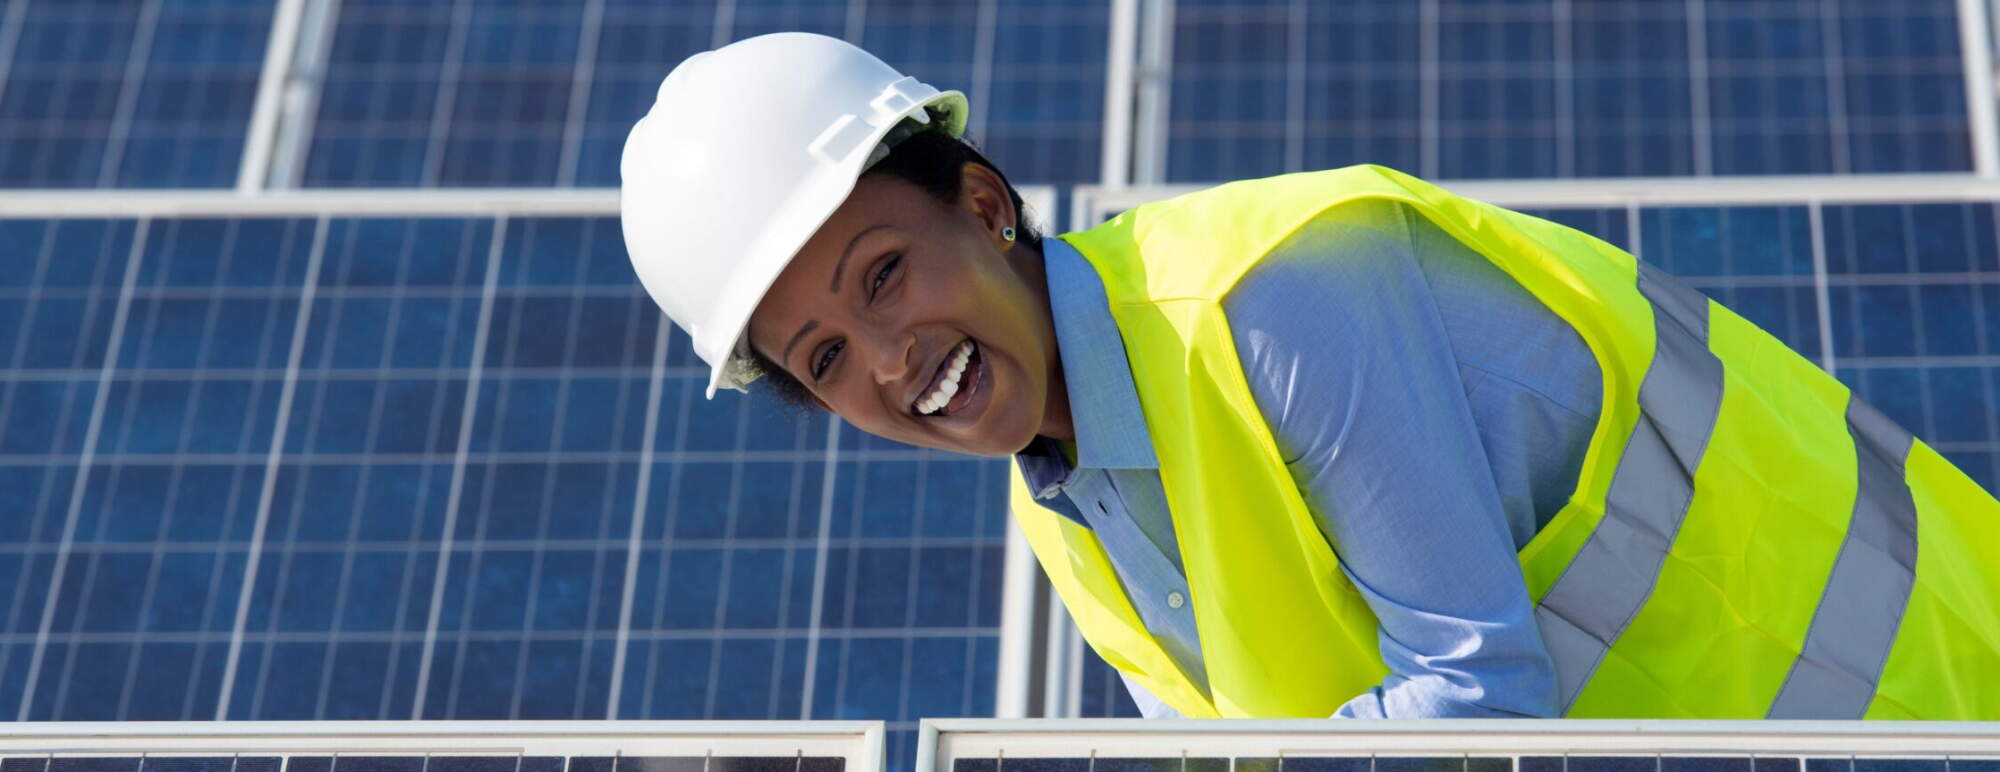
[[1224, 204, 1556, 718]]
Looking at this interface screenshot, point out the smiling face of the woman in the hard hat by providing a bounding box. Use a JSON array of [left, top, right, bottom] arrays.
[[750, 164, 1072, 456]]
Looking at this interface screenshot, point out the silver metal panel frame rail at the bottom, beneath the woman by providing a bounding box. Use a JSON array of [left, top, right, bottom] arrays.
[[916, 718, 2000, 772]]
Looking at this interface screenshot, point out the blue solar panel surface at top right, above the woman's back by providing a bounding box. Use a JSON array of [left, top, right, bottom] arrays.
[[1166, 0, 1972, 182]]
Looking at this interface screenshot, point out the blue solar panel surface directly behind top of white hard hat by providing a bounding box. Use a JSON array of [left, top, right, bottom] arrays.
[[304, 0, 1108, 186]]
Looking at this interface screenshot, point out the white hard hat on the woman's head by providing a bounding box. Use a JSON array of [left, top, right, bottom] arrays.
[[618, 32, 968, 398]]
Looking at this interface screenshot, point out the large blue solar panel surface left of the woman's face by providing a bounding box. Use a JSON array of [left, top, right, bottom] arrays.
[[0, 218, 1006, 772]]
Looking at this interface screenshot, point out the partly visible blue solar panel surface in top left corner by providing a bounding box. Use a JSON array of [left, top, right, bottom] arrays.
[[0, 0, 272, 188]]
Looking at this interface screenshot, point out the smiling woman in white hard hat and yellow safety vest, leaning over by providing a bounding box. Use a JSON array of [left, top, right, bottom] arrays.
[[622, 34, 2000, 718]]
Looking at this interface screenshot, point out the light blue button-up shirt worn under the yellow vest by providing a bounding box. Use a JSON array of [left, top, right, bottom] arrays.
[[1016, 204, 1600, 718]]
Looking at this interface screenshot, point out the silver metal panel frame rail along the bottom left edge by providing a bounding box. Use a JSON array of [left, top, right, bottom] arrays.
[[0, 720, 884, 772]]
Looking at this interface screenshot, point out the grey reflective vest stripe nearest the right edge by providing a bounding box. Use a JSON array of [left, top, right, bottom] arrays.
[[1770, 398, 1916, 718]]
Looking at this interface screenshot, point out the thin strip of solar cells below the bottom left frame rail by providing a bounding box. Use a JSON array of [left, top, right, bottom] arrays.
[[0, 754, 846, 772]]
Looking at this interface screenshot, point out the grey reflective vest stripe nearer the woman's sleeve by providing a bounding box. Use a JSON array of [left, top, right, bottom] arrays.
[[1534, 264, 1722, 712]]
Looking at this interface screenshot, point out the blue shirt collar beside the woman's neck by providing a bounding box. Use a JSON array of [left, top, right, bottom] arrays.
[[1016, 238, 1160, 498]]
